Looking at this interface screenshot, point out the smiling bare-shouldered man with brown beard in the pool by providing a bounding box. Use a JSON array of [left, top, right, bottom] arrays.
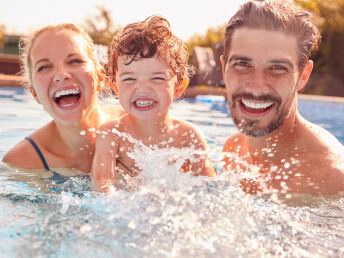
[[221, 0, 344, 195]]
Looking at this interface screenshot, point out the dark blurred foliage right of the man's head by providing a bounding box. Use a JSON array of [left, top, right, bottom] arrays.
[[295, 0, 344, 96]]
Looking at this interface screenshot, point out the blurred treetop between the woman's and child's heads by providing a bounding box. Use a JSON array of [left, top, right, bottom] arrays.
[[84, 6, 120, 46]]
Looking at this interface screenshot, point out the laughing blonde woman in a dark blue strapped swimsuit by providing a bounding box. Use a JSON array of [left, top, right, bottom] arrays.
[[3, 24, 123, 177]]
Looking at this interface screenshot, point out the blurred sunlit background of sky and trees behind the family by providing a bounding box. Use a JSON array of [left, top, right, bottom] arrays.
[[0, 0, 344, 97]]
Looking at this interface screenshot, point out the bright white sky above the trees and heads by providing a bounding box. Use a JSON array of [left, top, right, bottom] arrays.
[[0, 0, 245, 40]]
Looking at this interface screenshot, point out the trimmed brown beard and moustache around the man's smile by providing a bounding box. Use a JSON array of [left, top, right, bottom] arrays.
[[229, 93, 291, 137]]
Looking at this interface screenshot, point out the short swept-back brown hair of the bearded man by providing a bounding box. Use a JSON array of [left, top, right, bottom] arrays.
[[224, 0, 320, 72]]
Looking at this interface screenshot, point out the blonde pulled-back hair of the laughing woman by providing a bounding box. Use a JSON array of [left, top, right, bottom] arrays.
[[19, 23, 101, 86]]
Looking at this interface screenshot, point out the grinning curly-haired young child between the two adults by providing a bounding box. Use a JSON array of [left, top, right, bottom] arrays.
[[92, 16, 216, 191]]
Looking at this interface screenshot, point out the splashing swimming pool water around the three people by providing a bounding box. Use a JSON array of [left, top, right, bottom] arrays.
[[0, 88, 344, 257]]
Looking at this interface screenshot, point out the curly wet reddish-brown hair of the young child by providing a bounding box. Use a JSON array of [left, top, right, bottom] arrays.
[[107, 16, 192, 83]]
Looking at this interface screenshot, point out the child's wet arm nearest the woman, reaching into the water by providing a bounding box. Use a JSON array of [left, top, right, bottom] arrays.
[[91, 124, 118, 192]]
